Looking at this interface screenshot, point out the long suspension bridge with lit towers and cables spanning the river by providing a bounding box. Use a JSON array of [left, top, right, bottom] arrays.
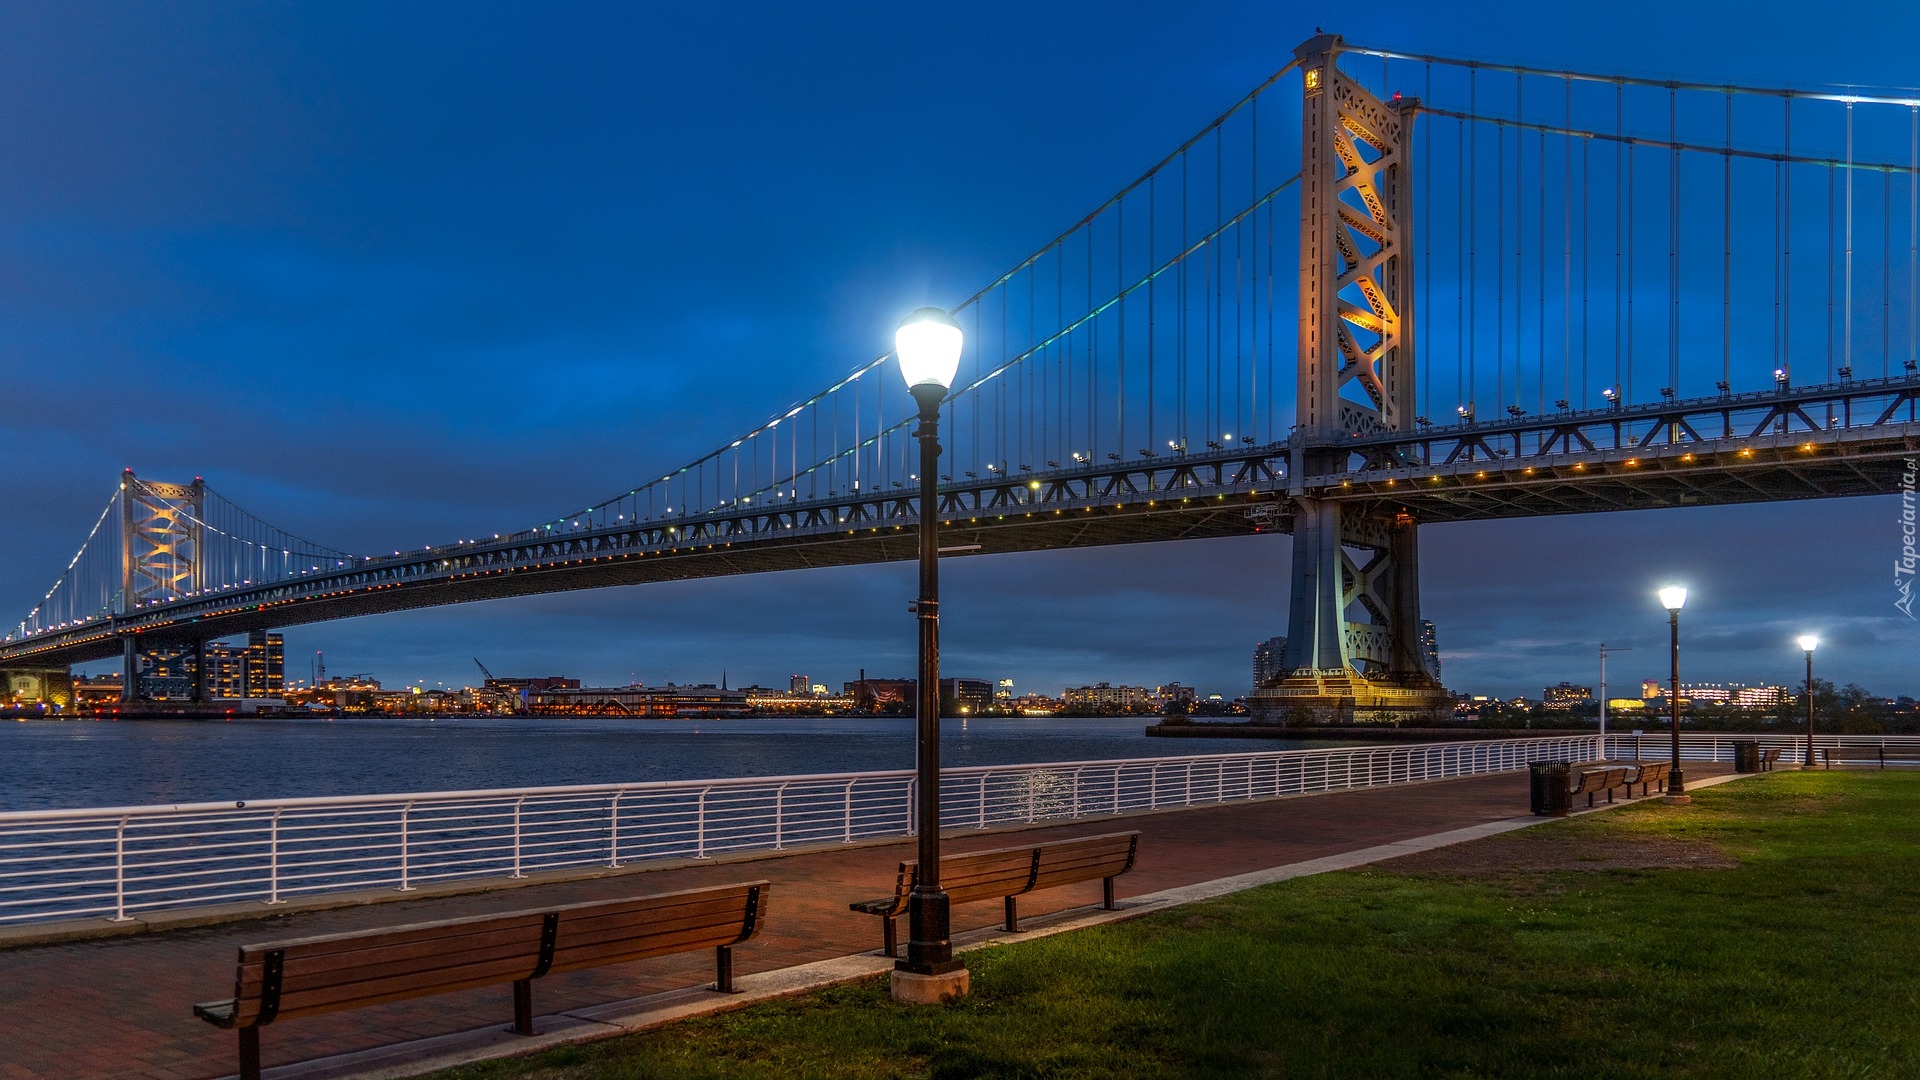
[[0, 35, 1920, 715]]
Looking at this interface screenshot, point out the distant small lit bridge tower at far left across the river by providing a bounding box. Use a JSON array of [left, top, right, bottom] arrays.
[[117, 469, 207, 701]]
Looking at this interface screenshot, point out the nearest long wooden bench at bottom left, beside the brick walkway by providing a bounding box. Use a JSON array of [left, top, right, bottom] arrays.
[[194, 880, 770, 1080]]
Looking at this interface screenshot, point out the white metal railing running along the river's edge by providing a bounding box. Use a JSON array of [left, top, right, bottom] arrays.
[[0, 736, 1697, 922]]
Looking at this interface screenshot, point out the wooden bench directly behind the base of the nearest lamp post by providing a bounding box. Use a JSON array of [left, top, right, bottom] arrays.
[[847, 832, 1140, 957]]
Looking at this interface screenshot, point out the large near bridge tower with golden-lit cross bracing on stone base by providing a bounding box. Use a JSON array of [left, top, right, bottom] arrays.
[[1250, 35, 1448, 723]]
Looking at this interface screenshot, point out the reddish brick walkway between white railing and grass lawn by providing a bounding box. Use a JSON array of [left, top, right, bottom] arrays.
[[0, 773, 1526, 1080]]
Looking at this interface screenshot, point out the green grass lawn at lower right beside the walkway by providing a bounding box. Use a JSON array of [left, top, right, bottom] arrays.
[[428, 771, 1920, 1080]]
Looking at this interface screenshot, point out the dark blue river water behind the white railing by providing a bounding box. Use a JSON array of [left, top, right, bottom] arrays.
[[0, 717, 1308, 811]]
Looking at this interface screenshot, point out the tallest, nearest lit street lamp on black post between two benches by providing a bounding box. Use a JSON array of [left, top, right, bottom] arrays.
[[893, 307, 968, 1003]]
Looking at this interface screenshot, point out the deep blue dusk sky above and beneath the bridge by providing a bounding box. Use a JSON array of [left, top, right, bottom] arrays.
[[0, 2, 1920, 696]]
